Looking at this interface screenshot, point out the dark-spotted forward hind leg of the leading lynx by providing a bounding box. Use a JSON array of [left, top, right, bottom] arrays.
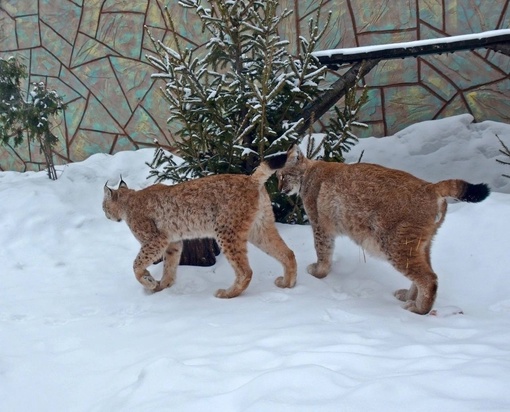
[[215, 236, 253, 298]]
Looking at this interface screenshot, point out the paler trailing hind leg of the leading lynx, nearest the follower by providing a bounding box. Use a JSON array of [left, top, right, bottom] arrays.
[[249, 218, 297, 288]]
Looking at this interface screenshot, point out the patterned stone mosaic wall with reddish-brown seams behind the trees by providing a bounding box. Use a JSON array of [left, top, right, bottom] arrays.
[[0, 0, 510, 170]]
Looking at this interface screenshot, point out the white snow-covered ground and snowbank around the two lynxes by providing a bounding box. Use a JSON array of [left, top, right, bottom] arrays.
[[0, 115, 510, 412]]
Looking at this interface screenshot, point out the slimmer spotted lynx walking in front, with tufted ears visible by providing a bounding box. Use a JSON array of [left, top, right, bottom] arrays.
[[103, 155, 296, 298]]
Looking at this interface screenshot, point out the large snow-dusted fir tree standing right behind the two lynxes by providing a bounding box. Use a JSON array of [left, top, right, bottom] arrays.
[[148, 0, 364, 221]]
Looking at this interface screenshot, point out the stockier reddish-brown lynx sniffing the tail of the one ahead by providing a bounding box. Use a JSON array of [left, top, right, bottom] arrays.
[[277, 146, 490, 314]]
